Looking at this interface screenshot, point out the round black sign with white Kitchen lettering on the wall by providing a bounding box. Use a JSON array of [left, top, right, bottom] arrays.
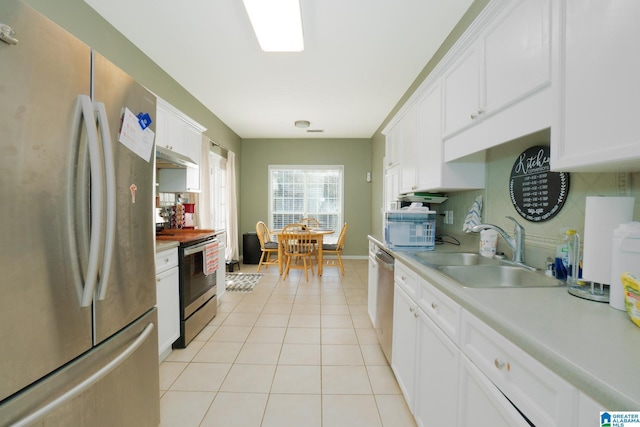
[[509, 146, 569, 222]]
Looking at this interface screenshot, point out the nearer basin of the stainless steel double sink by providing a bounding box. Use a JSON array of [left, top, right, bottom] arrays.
[[439, 264, 565, 288]]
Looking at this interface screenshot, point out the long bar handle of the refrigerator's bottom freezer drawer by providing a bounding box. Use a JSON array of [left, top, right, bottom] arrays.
[[12, 323, 154, 427]]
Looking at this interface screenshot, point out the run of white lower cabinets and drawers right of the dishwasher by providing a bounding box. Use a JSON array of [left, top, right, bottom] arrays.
[[391, 259, 584, 427]]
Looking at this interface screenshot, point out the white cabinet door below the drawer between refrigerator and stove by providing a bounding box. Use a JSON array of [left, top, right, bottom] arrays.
[[156, 266, 180, 358]]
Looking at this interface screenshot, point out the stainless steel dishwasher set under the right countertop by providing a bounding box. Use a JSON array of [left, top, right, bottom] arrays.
[[375, 248, 394, 364]]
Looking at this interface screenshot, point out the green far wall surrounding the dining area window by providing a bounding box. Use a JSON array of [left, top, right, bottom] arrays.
[[238, 139, 371, 256]]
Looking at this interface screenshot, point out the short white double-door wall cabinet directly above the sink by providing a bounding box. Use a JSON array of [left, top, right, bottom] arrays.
[[442, 0, 551, 161]]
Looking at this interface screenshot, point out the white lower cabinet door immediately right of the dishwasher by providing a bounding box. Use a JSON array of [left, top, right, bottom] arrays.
[[391, 284, 418, 413]]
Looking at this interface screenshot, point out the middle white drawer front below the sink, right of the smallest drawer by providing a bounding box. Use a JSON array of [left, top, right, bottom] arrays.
[[418, 278, 462, 344]]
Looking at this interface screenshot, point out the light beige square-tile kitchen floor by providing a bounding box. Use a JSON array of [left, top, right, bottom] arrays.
[[160, 260, 415, 427]]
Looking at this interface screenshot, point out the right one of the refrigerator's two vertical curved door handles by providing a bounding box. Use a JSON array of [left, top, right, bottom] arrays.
[[95, 102, 116, 300]]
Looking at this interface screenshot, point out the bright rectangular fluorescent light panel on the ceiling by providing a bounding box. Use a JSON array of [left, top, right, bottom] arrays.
[[242, 0, 304, 52]]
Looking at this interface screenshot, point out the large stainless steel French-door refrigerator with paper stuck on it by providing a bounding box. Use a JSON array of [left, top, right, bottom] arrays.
[[0, 0, 160, 426]]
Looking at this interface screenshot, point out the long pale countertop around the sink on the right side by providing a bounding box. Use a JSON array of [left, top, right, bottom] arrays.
[[369, 236, 640, 411]]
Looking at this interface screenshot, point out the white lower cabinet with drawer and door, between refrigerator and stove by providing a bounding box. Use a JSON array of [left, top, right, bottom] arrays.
[[156, 248, 180, 360]]
